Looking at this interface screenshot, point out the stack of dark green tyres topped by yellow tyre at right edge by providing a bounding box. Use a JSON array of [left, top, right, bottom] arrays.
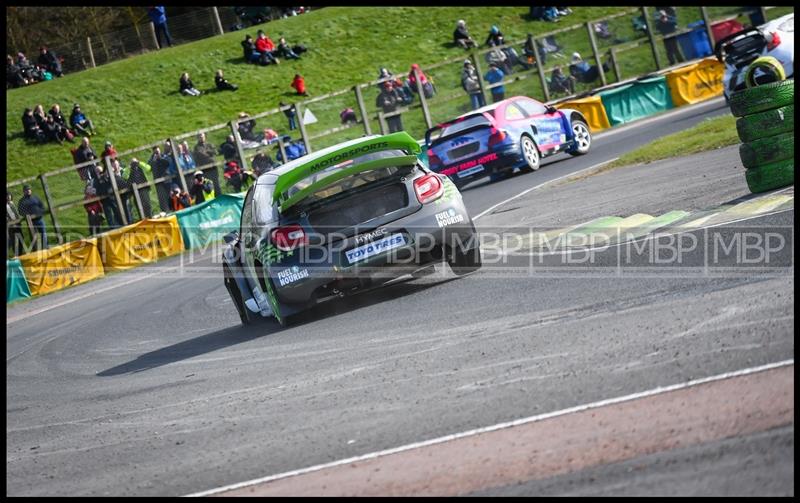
[[730, 58, 794, 192]]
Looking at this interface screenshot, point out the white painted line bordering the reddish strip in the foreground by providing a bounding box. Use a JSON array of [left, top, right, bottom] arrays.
[[187, 359, 794, 497]]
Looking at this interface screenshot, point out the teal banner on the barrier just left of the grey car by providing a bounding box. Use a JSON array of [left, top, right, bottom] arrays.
[[175, 194, 244, 250]]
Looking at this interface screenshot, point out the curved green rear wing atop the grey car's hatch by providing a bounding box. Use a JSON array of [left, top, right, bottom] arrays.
[[272, 131, 422, 211]]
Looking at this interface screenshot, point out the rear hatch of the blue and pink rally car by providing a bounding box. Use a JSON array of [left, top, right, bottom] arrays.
[[425, 114, 496, 174]]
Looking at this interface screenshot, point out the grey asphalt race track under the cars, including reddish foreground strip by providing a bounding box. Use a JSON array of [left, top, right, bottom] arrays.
[[6, 99, 794, 496]]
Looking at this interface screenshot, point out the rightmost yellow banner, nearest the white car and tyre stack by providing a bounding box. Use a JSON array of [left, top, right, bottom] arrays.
[[664, 58, 725, 107]]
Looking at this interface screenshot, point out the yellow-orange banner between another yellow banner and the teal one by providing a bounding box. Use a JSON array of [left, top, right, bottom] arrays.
[[97, 215, 183, 270]]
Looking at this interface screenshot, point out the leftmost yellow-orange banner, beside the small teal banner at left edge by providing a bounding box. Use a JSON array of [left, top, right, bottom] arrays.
[[17, 238, 105, 295]]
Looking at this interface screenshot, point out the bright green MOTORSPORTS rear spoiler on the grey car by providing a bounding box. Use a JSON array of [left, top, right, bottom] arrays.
[[272, 131, 422, 210]]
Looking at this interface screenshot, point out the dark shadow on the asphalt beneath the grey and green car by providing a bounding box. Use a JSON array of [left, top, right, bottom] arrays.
[[96, 276, 459, 377]]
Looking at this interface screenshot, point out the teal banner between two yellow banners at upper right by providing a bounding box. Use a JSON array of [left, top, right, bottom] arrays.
[[598, 75, 673, 126]]
